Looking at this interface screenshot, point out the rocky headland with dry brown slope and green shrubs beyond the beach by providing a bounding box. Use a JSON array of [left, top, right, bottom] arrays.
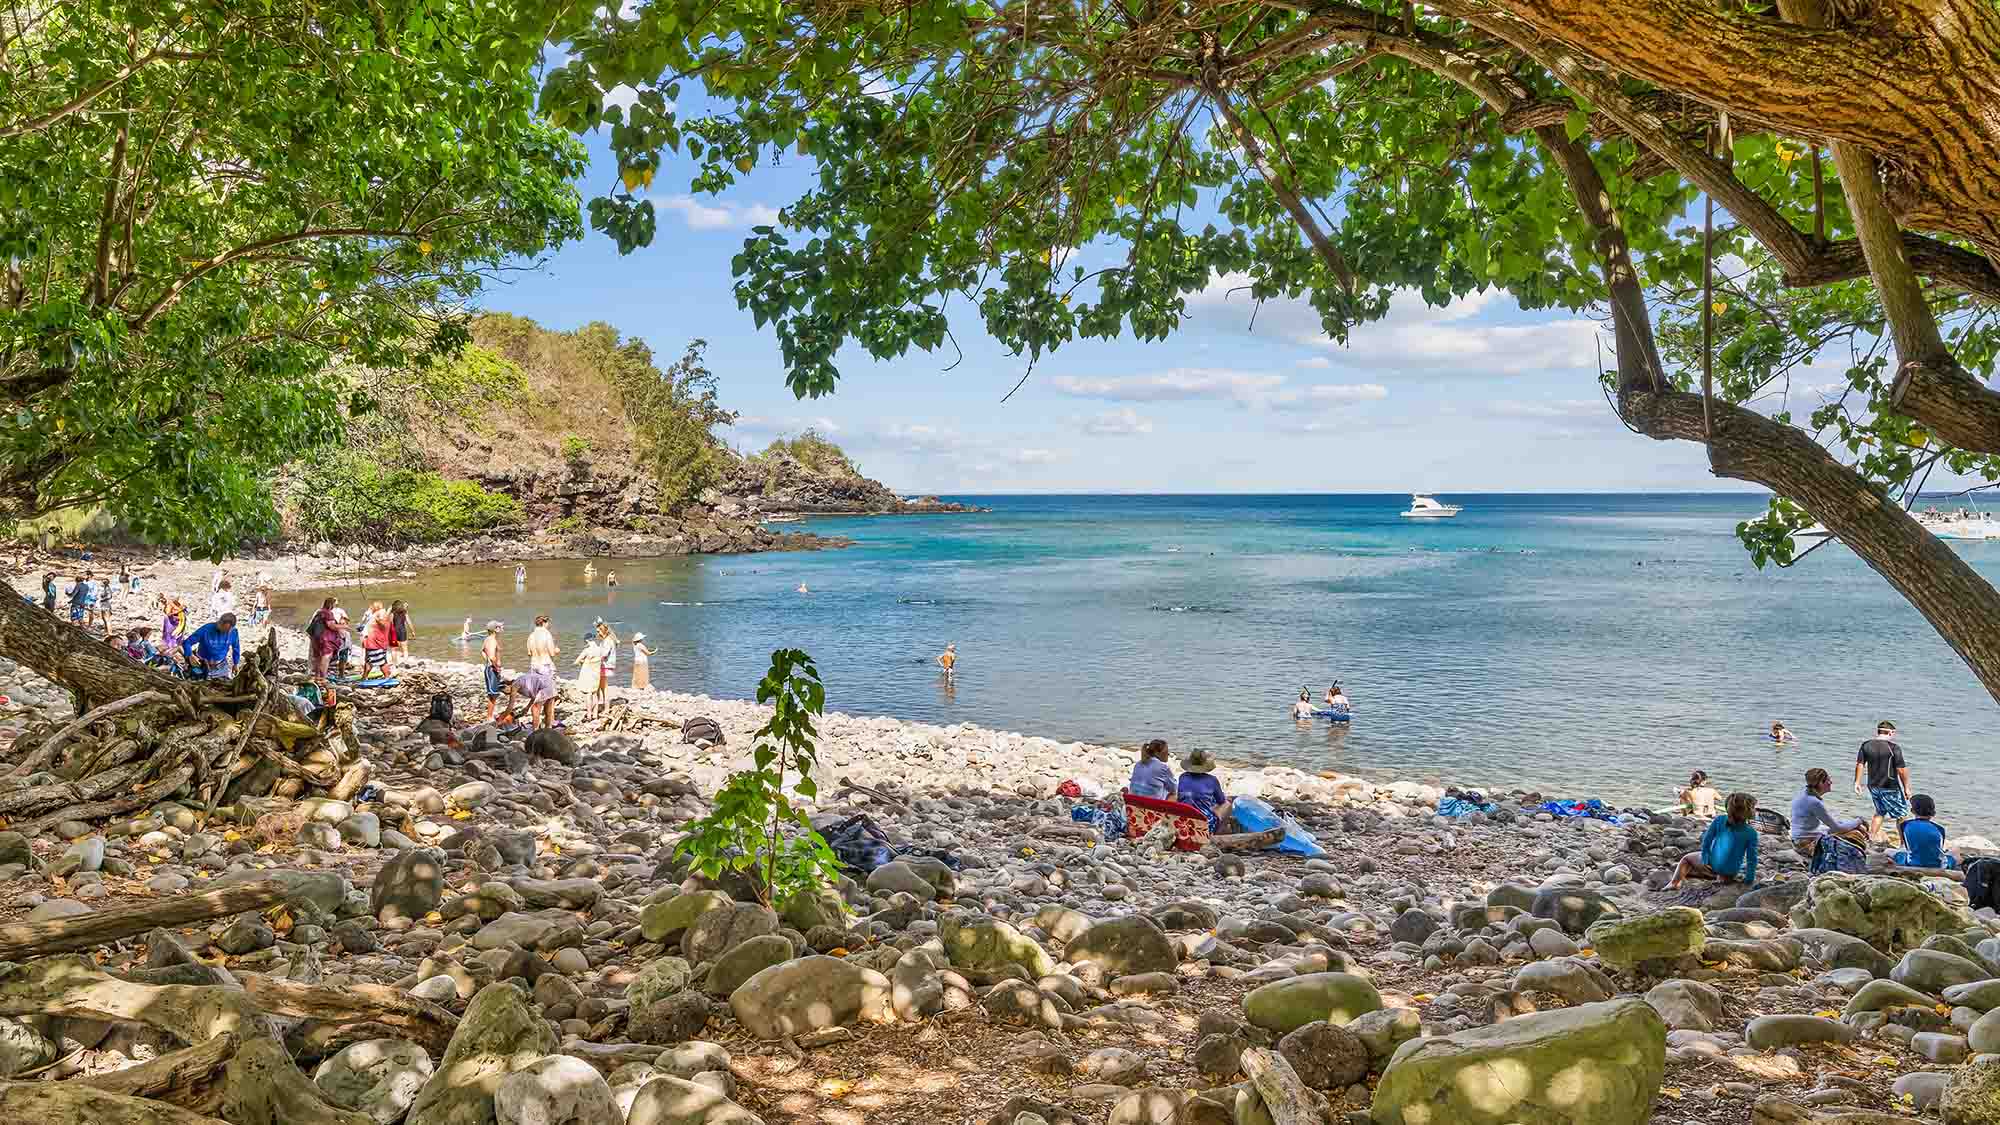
[[278, 314, 970, 556]]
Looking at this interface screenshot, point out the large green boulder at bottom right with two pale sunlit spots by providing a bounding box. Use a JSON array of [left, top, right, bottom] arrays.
[[1372, 999, 1666, 1125]]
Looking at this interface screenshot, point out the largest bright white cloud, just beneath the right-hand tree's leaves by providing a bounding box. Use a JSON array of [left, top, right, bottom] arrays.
[[1188, 274, 1600, 376]]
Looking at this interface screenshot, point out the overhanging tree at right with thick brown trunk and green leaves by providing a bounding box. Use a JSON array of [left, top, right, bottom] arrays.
[[528, 0, 2000, 695]]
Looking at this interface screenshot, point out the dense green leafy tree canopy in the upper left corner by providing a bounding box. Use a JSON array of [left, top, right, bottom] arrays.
[[0, 0, 584, 552]]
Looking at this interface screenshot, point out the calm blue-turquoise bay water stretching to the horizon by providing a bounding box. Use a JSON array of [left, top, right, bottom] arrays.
[[282, 492, 2000, 835]]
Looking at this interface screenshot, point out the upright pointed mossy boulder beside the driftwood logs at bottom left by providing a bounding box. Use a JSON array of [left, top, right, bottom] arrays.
[[408, 981, 556, 1125]]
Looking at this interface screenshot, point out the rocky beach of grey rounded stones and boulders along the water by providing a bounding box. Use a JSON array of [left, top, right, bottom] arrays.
[[0, 567, 2000, 1125]]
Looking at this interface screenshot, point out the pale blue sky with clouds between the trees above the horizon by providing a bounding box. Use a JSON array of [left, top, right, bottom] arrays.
[[482, 107, 1784, 492]]
